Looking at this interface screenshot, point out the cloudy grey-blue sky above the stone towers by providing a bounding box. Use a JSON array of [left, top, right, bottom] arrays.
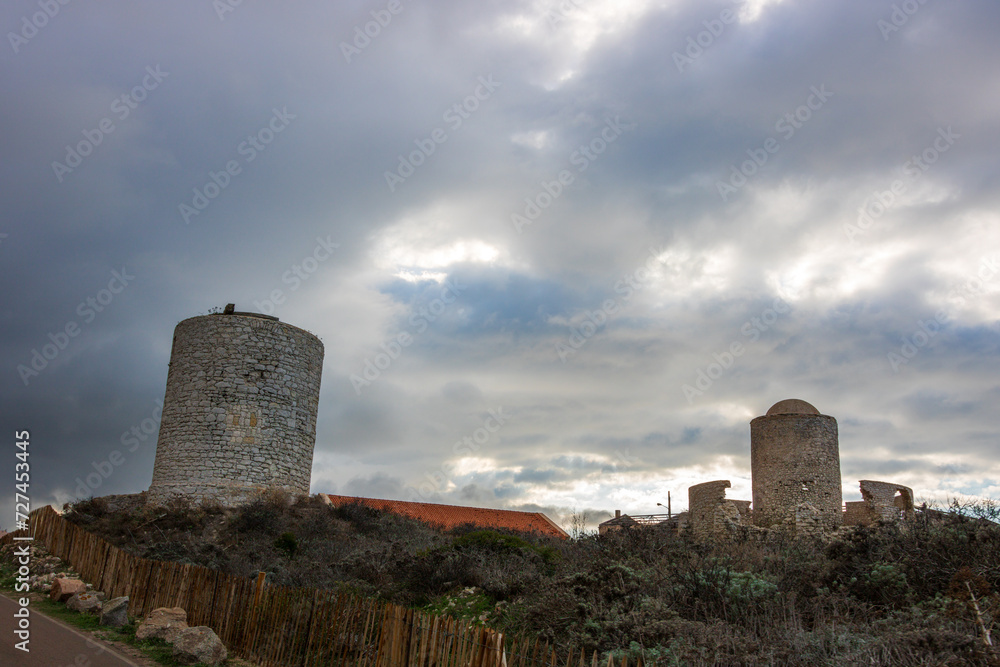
[[0, 0, 1000, 527]]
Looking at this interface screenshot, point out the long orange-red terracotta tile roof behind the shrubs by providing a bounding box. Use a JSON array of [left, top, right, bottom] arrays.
[[320, 493, 568, 538]]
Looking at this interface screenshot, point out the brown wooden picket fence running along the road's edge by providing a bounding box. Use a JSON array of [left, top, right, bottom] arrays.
[[0, 507, 641, 667]]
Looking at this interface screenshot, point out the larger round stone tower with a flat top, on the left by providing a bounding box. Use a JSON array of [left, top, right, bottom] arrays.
[[149, 304, 323, 505]]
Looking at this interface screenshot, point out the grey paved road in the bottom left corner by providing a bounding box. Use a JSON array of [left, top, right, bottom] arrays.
[[0, 595, 139, 667]]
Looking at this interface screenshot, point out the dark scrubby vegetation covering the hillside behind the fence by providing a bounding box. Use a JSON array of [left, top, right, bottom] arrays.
[[67, 494, 1000, 666]]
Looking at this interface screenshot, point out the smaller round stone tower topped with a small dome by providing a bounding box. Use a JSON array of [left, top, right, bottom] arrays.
[[750, 399, 843, 530]]
